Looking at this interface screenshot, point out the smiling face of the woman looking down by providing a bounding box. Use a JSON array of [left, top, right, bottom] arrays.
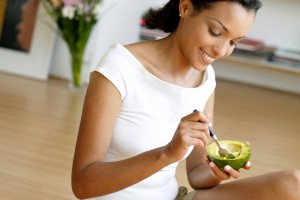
[[176, 0, 255, 71]]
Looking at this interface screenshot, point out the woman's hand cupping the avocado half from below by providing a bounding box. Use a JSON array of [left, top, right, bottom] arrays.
[[205, 156, 251, 181]]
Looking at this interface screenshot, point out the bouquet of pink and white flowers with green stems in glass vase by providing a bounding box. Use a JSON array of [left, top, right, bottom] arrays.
[[41, 0, 102, 88]]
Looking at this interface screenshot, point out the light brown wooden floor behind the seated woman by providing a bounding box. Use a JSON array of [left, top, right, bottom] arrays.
[[0, 73, 300, 200]]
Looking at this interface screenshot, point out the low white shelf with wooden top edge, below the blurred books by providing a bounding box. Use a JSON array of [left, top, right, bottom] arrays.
[[213, 56, 300, 94]]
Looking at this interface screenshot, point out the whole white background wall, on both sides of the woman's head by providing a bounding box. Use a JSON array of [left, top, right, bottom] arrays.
[[50, 0, 300, 81]]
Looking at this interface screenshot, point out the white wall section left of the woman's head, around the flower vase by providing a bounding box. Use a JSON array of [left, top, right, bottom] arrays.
[[50, 0, 166, 79]]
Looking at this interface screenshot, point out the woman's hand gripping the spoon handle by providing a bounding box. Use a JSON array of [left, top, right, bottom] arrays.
[[166, 111, 209, 161]]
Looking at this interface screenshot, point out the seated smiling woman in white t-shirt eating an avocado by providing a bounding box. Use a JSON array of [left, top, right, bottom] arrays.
[[72, 0, 300, 200]]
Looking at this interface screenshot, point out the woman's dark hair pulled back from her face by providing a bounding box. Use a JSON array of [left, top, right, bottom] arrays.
[[145, 0, 262, 33]]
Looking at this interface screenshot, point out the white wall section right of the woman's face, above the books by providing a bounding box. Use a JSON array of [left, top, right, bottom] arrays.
[[248, 0, 300, 50]]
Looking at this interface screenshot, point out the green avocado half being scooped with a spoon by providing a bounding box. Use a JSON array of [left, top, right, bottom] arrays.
[[206, 140, 251, 170]]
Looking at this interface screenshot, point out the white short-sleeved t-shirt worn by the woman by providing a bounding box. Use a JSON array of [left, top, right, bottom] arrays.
[[95, 44, 216, 200]]
